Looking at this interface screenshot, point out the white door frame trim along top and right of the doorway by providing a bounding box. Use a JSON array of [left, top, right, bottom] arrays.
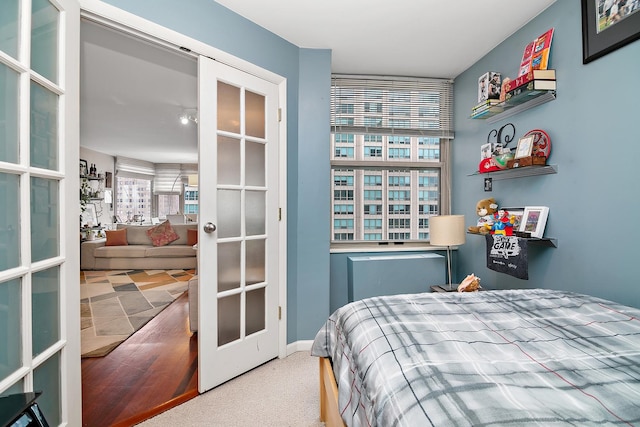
[[79, 0, 287, 358]]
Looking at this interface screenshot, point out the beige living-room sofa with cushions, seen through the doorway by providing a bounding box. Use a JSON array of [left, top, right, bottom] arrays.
[[80, 223, 198, 270]]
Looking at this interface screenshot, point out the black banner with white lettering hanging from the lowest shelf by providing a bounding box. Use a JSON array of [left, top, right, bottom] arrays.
[[486, 234, 529, 280]]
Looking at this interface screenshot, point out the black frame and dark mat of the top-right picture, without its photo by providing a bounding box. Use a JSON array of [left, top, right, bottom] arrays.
[[581, 0, 640, 64]]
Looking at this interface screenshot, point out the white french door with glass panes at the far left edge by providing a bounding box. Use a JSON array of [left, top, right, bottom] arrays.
[[0, 0, 82, 425]]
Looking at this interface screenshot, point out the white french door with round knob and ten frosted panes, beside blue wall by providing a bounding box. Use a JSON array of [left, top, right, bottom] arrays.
[[198, 56, 279, 393]]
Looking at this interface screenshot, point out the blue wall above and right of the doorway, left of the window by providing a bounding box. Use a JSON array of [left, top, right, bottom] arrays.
[[105, 0, 331, 343]]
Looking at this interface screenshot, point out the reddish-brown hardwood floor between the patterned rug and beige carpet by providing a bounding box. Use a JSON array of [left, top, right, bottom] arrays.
[[82, 292, 198, 427]]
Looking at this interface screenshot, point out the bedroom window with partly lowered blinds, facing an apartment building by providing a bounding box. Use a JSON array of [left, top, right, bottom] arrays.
[[330, 75, 454, 242]]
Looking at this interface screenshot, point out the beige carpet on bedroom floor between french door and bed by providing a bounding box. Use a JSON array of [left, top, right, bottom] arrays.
[[138, 352, 324, 427]]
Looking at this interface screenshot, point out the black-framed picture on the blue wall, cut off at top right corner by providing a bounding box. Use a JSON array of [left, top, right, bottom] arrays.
[[581, 0, 640, 64]]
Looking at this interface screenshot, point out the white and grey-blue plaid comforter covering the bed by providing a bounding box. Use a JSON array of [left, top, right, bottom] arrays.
[[311, 289, 640, 427]]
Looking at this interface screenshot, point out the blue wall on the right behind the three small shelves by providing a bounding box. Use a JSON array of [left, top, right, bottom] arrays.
[[452, 0, 640, 307]]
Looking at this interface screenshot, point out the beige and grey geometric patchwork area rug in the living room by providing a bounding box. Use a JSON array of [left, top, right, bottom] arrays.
[[80, 270, 195, 357]]
